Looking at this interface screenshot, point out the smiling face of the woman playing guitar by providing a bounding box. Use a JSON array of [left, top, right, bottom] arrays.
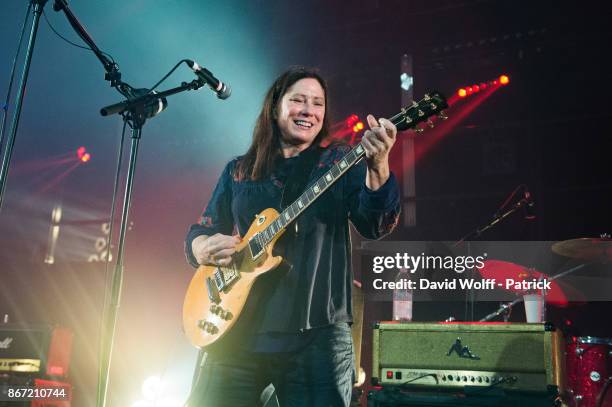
[[276, 78, 325, 151]]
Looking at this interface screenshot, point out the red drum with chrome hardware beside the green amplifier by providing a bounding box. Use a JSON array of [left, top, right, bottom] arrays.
[[565, 336, 612, 407]]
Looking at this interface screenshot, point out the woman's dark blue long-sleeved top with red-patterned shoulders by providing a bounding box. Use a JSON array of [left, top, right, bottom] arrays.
[[185, 146, 400, 344]]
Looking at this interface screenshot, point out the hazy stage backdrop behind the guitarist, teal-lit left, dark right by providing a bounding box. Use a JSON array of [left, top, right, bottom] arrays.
[[0, 0, 612, 406]]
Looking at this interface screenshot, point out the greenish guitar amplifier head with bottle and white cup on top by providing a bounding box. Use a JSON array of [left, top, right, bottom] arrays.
[[372, 322, 565, 394]]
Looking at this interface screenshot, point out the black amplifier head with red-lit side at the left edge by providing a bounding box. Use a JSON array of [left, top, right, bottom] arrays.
[[0, 324, 73, 377]]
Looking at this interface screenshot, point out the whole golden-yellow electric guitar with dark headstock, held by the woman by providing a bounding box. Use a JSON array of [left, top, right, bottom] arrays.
[[183, 92, 448, 348]]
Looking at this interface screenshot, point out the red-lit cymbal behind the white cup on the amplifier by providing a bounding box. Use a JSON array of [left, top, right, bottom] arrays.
[[478, 260, 573, 307]]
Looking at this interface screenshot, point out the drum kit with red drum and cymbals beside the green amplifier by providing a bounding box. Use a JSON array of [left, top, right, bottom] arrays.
[[480, 237, 612, 407]]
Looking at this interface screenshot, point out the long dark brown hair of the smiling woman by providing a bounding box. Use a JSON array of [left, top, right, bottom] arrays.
[[234, 67, 329, 180]]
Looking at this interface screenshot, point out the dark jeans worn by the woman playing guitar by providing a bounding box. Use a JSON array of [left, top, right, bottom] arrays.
[[187, 323, 354, 407]]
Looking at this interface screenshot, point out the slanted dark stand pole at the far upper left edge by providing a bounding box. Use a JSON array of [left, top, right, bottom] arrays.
[[0, 0, 47, 211]]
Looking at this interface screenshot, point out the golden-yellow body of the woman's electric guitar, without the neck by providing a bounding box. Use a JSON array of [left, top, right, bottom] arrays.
[[183, 208, 283, 348]]
